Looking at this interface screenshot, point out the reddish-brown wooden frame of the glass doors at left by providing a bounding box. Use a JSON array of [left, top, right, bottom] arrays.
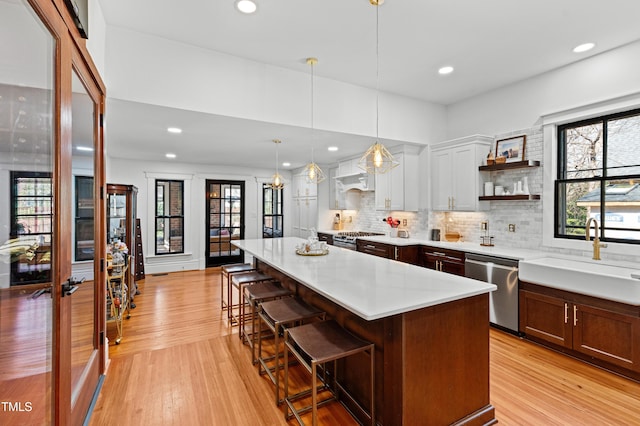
[[27, 0, 106, 425]]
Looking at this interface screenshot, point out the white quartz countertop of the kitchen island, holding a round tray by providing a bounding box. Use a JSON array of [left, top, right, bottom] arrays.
[[232, 237, 496, 321]]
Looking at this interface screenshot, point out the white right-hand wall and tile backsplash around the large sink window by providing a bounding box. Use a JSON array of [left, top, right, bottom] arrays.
[[442, 42, 640, 262]]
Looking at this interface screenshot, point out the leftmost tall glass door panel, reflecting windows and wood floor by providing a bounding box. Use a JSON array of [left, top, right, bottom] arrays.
[[0, 1, 54, 425]]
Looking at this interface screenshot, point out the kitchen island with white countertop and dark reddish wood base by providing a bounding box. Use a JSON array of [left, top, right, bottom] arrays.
[[233, 238, 496, 425]]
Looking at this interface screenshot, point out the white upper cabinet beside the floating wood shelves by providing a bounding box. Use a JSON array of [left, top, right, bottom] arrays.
[[431, 135, 493, 211]]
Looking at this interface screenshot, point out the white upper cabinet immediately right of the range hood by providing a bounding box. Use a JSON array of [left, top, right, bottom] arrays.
[[375, 146, 420, 212]]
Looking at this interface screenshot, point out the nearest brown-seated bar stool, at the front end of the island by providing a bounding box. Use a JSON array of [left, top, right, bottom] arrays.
[[284, 320, 376, 426]]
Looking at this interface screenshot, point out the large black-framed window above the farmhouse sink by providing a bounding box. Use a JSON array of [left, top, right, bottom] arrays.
[[555, 109, 640, 244]]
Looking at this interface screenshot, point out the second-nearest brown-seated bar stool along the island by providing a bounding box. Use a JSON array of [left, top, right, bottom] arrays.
[[258, 297, 326, 405]]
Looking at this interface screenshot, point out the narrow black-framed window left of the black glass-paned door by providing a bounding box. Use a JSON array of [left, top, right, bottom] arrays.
[[155, 180, 184, 255]]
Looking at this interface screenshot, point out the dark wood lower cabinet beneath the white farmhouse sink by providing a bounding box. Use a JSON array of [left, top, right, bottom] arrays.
[[520, 282, 640, 380]]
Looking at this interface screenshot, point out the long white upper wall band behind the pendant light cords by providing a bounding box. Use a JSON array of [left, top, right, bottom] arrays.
[[106, 27, 446, 144]]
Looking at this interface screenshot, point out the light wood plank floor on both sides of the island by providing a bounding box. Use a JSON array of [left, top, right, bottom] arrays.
[[91, 269, 640, 426]]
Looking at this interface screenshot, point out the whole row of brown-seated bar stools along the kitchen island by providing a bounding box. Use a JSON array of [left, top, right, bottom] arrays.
[[225, 264, 375, 426]]
